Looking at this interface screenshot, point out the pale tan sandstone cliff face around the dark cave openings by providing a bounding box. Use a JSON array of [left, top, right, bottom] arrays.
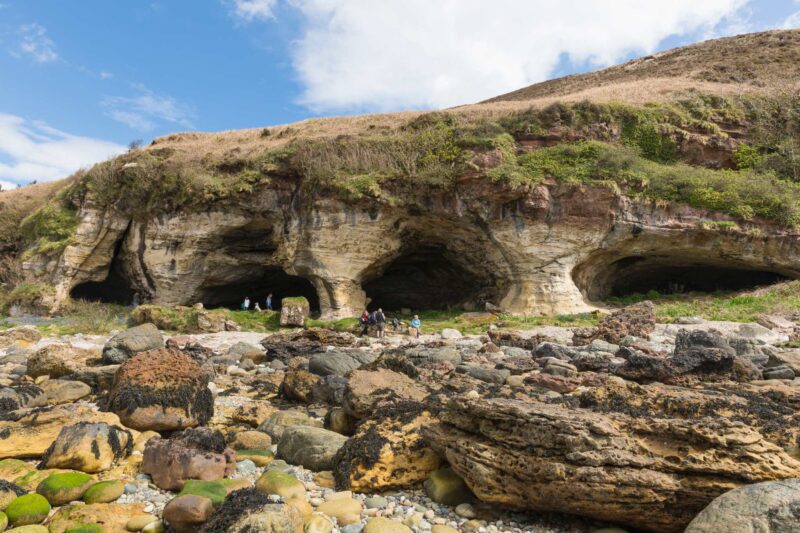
[[29, 177, 800, 323]]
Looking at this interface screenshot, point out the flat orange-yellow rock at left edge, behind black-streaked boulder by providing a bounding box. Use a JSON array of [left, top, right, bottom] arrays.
[[0, 403, 121, 459]]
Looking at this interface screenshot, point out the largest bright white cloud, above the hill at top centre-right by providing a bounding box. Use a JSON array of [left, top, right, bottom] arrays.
[[289, 0, 747, 111]]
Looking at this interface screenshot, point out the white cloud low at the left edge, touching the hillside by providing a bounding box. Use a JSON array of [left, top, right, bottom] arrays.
[[0, 113, 125, 188]]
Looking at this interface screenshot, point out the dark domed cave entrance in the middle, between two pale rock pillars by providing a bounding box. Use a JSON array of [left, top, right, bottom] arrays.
[[363, 246, 494, 311]]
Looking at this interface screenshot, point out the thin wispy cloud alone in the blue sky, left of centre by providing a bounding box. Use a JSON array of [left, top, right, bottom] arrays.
[[100, 84, 194, 132]]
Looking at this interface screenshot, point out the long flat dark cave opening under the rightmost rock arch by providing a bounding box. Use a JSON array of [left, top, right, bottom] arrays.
[[573, 251, 797, 301]]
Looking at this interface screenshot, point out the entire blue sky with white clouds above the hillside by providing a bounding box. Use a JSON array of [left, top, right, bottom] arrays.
[[0, 0, 800, 188]]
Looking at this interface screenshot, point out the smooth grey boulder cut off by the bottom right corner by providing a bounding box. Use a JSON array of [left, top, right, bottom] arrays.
[[685, 479, 800, 533]]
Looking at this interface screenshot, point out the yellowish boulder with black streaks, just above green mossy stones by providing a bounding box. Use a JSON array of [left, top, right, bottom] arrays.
[[39, 422, 133, 473]]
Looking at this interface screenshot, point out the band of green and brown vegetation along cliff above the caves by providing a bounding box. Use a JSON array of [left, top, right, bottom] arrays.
[[53, 92, 800, 227]]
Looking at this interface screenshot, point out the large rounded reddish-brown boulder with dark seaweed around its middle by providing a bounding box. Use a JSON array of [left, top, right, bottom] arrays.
[[108, 348, 214, 431]]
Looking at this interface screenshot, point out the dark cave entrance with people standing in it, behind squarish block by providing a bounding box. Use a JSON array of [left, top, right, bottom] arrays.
[[200, 266, 319, 313]]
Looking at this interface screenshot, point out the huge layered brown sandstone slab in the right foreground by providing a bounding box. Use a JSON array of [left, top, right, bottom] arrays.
[[423, 385, 800, 532]]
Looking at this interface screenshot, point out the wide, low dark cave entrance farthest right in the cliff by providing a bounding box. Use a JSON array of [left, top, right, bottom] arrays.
[[586, 256, 789, 300]]
